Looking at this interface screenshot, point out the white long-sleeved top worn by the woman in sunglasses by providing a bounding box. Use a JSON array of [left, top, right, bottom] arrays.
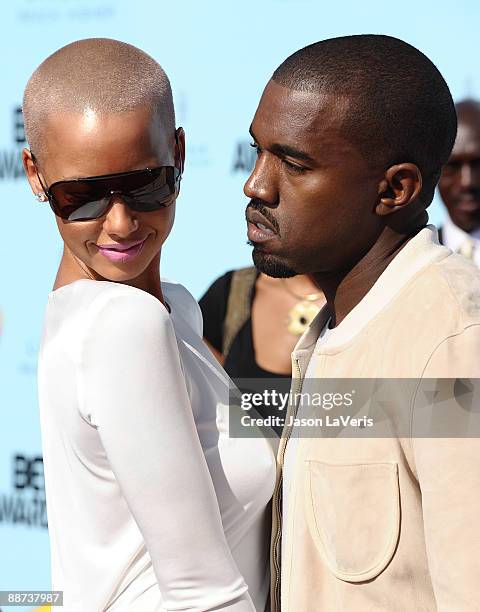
[[38, 279, 275, 612]]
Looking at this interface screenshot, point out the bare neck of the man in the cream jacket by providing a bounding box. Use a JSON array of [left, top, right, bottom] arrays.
[[312, 228, 414, 327]]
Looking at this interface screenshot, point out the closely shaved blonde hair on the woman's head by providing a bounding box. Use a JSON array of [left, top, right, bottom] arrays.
[[23, 38, 175, 157]]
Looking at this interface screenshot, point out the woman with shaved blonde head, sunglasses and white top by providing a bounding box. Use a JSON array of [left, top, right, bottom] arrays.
[[23, 39, 275, 612]]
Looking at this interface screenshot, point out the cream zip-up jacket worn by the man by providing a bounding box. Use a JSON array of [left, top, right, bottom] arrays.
[[272, 226, 480, 612]]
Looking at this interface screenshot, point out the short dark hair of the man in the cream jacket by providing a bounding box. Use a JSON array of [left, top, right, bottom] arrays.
[[272, 34, 457, 201]]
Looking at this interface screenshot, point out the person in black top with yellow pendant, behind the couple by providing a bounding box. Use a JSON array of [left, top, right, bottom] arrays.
[[199, 267, 325, 435]]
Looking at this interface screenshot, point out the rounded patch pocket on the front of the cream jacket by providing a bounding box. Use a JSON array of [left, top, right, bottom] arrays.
[[305, 460, 400, 582]]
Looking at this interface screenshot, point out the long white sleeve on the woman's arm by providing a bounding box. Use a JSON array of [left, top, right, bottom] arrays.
[[77, 290, 255, 612]]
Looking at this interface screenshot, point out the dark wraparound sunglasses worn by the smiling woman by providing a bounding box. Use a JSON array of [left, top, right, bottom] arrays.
[[32, 153, 182, 221]]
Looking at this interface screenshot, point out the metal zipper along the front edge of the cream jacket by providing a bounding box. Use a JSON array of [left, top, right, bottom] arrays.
[[271, 358, 303, 612]]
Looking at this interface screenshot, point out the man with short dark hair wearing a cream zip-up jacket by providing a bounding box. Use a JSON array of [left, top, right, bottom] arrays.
[[244, 35, 480, 612]]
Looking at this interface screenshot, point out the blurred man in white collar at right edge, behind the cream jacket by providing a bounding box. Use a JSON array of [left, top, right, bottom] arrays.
[[438, 100, 480, 266]]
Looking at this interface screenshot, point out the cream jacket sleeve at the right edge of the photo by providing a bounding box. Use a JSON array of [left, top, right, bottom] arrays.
[[412, 325, 480, 612]]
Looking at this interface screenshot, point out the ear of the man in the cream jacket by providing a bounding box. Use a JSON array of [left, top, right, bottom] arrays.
[[375, 163, 422, 216]]
